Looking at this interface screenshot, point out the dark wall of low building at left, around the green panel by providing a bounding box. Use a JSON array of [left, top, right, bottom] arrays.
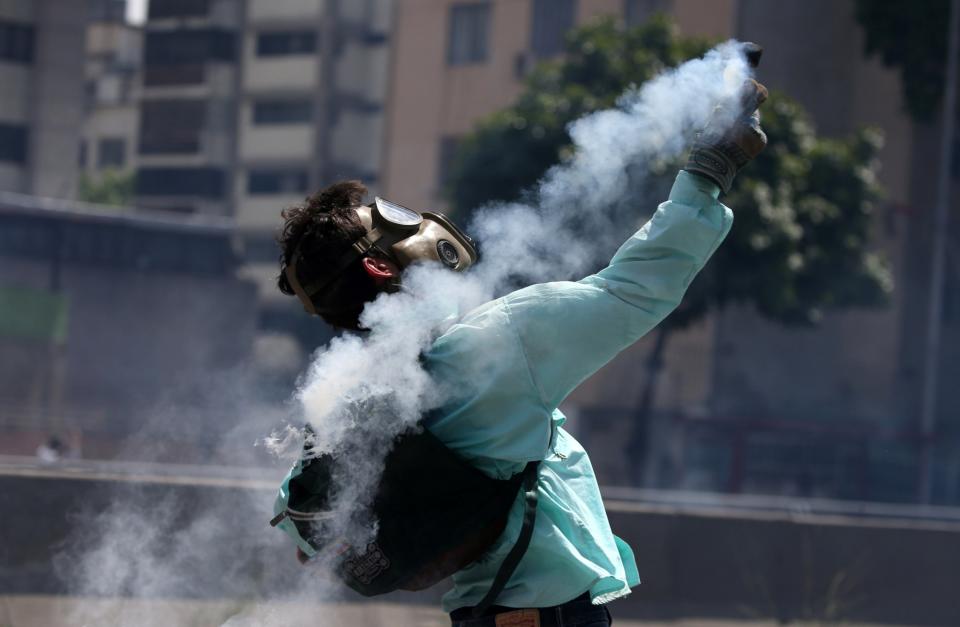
[[0, 257, 256, 457]]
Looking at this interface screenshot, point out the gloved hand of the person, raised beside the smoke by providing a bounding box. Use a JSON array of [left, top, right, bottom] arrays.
[[683, 78, 768, 193]]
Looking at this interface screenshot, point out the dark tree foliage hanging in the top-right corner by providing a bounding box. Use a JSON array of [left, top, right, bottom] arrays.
[[856, 0, 950, 121]]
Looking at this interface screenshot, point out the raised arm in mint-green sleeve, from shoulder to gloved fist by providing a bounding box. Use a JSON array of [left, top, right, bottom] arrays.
[[425, 81, 766, 461]]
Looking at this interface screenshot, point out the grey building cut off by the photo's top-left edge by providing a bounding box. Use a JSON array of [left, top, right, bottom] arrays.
[[0, 0, 87, 197]]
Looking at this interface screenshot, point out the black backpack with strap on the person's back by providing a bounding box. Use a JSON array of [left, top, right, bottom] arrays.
[[270, 421, 540, 615]]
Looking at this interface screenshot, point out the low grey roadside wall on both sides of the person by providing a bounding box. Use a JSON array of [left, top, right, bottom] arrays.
[[0, 465, 960, 626]]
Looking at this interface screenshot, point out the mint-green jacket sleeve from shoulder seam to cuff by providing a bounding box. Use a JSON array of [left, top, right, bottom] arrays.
[[502, 171, 733, 410]]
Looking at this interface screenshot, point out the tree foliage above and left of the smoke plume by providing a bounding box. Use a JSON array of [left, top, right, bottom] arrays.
[[449, 15, 709, 210]]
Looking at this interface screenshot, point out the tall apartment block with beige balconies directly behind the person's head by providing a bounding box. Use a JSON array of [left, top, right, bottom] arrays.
[[137, 0, 391, 245]]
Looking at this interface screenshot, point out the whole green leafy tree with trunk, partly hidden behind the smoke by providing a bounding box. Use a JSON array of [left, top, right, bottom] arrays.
[[449, 16, 891, 486]]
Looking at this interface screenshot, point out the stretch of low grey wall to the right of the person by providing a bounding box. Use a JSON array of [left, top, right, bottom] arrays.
[[609, 504, 960, 625]]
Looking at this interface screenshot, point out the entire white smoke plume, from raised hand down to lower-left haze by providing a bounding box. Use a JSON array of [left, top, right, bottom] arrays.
[[56, 41, 749, 626]]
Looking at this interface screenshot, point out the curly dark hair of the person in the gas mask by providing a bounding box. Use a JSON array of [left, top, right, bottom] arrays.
[[277, 181, 380, 330]]
